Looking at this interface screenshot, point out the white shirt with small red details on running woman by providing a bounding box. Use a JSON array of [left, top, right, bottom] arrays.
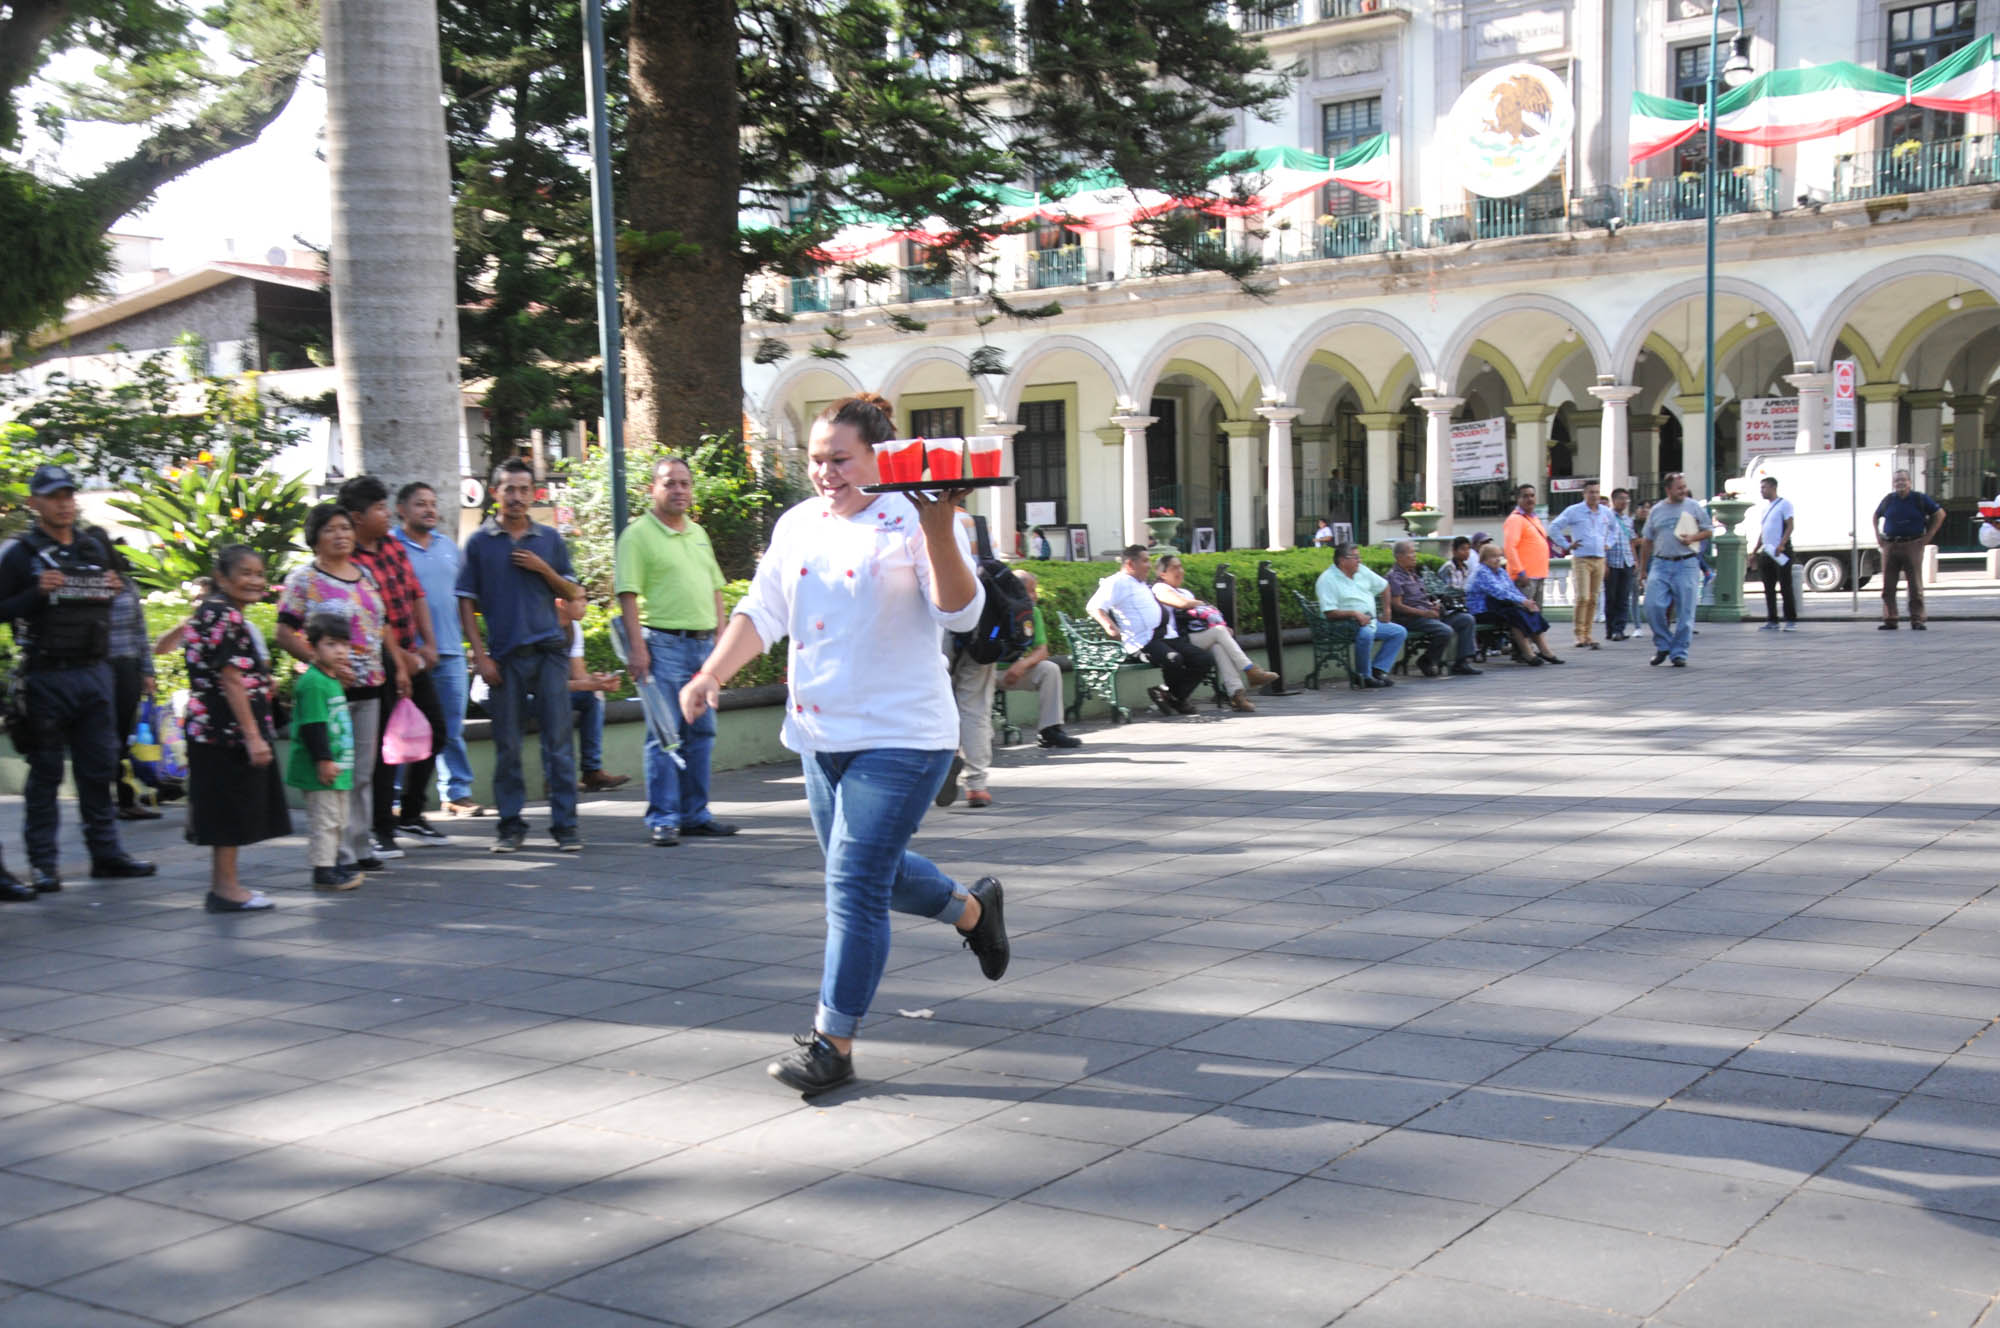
[[736, 494, 986, 754]]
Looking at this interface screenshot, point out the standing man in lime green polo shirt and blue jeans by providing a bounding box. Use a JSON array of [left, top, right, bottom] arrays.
[[612, 456, 736, 848]]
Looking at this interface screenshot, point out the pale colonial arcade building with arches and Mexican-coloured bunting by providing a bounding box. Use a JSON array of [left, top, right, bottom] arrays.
[[744, 0, 2000, 552]]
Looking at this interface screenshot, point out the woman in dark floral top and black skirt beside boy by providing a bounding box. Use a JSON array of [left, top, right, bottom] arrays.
[[182, 544, 292, 912]]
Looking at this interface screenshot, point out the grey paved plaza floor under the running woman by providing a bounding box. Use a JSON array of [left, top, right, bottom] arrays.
[[0, 622, 2000, 1328]]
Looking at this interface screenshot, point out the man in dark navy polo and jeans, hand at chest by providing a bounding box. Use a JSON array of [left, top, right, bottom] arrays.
[[458, 458, 584, 854]]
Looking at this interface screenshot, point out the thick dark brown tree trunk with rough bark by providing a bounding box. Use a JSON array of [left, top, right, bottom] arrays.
[[618, 0, 744, 452]]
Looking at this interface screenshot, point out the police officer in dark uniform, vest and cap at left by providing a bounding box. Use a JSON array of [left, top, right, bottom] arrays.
[[0, 466, 156, 898]]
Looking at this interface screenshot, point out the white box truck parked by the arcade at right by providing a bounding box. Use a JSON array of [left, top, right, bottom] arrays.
[[1724, 448, 1924, 590]]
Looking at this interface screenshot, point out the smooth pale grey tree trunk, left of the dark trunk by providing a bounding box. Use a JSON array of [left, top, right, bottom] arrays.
[[322, 0, 462, 496]]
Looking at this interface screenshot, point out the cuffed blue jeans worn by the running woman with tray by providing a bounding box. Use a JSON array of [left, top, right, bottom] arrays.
[[804, 748, 968, 1038]]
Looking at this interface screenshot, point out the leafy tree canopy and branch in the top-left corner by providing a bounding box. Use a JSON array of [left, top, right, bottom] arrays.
[[0, 0, 318, 342]]
